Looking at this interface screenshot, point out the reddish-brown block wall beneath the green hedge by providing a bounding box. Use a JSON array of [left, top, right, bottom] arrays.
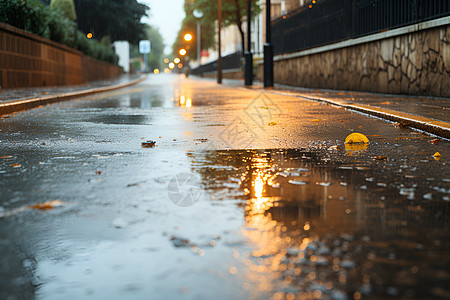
[[0, 23, 122, 88]]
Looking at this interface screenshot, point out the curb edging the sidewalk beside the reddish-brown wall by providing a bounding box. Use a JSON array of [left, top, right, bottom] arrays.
[[0, 76, 146, 116]]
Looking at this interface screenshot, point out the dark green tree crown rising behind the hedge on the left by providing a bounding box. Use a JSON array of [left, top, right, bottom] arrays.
[[75, 0, 149, 43]]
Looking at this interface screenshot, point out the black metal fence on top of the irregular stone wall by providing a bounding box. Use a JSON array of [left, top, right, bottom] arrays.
[[271, 0, 450, 54]]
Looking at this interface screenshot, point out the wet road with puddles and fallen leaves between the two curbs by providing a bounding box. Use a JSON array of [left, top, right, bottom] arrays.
[[0, 75, 450, 299]]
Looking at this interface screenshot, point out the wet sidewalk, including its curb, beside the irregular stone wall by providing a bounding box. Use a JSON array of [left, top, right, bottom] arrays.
[[224, 79, 450, 139]]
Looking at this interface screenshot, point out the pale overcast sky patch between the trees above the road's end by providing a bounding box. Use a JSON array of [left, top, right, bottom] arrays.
[[138, 0, 184, 53]]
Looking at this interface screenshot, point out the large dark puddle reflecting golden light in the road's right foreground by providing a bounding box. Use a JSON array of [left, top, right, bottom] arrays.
[[190, 150, 450, 299]]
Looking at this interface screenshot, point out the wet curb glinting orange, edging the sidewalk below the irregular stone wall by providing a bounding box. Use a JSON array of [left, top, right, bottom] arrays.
[[269, 90, 450, 139]]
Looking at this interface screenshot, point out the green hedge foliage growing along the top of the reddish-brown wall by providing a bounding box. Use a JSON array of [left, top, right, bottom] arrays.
[[0, 0, 118, 63]]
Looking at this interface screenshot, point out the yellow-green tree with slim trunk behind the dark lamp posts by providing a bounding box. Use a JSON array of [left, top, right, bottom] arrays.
[[187, 0, 261, 56]]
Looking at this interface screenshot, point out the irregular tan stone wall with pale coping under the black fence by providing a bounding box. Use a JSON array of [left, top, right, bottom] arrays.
[[258, 18, 450, 97]]
